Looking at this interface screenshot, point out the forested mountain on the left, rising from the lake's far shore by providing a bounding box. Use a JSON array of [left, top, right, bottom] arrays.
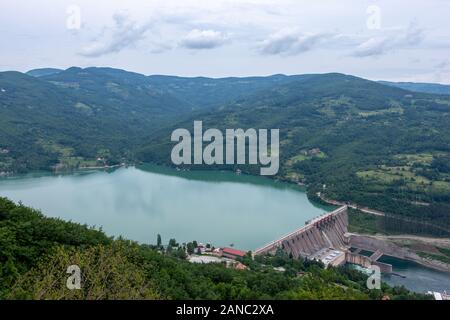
[[0, 68, 192, 172]]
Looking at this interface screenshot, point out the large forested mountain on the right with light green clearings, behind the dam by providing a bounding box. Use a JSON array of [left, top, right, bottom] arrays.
[[138, 74, 450, 235]]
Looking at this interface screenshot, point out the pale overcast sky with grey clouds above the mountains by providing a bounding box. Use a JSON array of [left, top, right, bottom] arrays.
[[0, 0, 450, 84]]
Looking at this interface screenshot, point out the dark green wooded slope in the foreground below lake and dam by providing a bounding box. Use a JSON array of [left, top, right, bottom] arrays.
[[0, 198, 430, 300]]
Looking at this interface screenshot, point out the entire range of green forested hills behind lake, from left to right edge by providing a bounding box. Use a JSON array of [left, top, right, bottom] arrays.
[[0, 68, 450, 235]]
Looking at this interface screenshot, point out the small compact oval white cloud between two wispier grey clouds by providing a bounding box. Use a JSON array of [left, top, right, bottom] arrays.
[[180, 29, 229, 50]]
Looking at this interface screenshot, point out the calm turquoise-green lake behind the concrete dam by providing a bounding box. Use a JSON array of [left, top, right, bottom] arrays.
[[0, 165, 331, 250]]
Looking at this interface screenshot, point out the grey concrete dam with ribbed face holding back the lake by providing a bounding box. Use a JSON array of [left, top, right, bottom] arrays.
[[254, 206, 392, 273]]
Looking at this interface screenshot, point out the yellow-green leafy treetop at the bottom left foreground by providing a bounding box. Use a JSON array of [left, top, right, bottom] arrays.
[[7, 242, 160, 300]]
